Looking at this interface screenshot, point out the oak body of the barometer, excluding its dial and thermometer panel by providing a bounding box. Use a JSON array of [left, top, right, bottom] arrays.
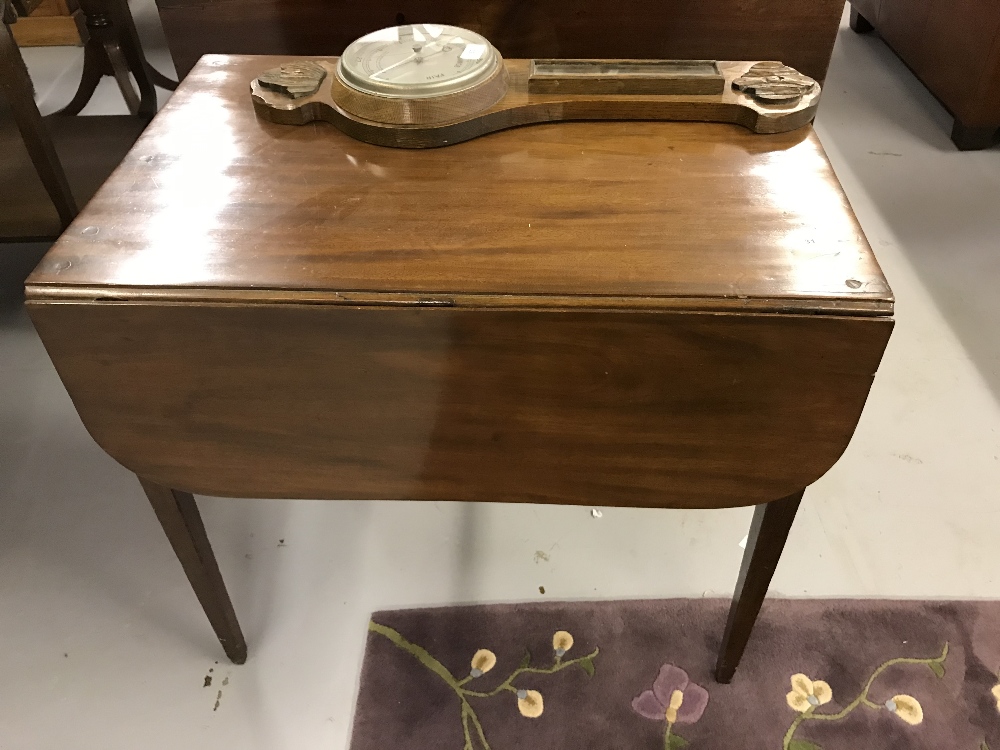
[[251, 60, 821, 148]]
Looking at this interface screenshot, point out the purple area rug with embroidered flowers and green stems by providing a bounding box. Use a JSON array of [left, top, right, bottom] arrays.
[[351, 599, 1000, 750]]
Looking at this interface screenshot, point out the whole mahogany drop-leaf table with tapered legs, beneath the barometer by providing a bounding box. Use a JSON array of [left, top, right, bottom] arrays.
[[27, 56, 893, 682]]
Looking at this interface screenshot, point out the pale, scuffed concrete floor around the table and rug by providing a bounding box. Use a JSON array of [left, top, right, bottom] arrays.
[[0, 3, 1000, 750]]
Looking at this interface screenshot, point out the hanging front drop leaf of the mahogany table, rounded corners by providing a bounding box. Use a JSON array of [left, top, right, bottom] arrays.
[[29, 302, 892, 508]]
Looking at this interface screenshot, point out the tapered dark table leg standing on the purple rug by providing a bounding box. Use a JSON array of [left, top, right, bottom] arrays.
[[715, 490, 804, 683]]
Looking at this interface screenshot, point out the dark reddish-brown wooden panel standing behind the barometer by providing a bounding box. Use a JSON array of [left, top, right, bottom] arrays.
[[157, 0, 844, 83]]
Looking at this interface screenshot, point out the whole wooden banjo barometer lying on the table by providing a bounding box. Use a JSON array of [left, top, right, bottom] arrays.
[[251, 24, 820, 148]]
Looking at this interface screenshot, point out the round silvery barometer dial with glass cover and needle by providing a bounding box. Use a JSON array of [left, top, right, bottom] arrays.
[[337, 23, 502, 99]]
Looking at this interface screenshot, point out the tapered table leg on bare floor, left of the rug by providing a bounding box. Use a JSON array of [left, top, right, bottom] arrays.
[[139, 477, 247, 664]]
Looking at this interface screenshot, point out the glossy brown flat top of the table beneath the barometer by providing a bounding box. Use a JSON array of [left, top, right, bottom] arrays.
[[28, 55, 892, 315]]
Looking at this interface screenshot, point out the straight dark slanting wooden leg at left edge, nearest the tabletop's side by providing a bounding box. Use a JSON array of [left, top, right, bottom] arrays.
[[0, 19, 77, 228]]
